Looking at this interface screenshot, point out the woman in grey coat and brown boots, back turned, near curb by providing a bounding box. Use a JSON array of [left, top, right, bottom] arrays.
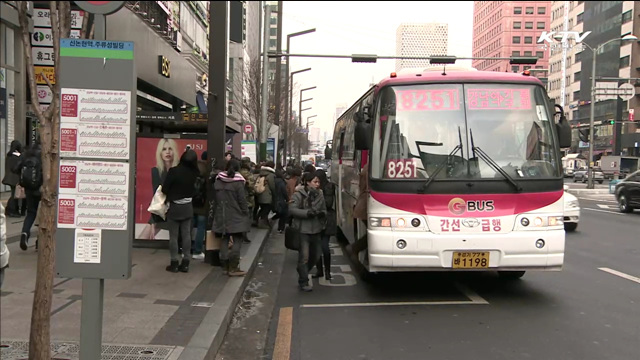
[[213, 159, 251, 276]]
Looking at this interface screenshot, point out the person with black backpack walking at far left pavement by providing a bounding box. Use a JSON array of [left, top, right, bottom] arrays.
[[13, 141, 44, 251]]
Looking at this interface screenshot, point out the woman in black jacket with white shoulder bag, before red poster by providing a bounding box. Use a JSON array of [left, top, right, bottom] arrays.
[[162, 149, 199, 273]]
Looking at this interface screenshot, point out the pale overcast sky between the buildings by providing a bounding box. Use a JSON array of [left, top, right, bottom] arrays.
[[282, 1, 473, 138]]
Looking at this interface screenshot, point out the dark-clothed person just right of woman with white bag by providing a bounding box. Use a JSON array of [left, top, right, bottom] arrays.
[[191, 151, 207, 260]]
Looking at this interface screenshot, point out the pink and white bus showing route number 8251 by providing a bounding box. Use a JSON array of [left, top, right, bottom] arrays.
[[327, 70, 571, 278]]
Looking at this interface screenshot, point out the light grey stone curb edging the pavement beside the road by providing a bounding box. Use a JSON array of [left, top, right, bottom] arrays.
[[178, 230, 271, 360]]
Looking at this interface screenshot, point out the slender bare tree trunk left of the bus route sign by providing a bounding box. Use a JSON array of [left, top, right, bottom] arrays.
[[15, 1, 82, 360]]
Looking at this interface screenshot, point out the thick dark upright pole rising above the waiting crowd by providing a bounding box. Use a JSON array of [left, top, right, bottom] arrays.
[[207, 1, 229, 174]]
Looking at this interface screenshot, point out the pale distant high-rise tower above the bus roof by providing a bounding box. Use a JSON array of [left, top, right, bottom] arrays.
[[396, 23, 449, 71]]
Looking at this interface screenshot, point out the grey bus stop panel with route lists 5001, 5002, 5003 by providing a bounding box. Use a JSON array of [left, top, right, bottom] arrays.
[[54, 39, 136, 279]]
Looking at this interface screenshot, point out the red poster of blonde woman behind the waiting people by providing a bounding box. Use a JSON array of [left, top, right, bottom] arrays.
[[135, 137, 207, 240]]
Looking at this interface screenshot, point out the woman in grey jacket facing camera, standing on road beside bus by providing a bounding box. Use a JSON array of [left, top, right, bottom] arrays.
[[289, 173, 327, 292]]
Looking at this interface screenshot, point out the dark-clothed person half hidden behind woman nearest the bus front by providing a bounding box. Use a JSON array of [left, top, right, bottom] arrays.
[[313, 169, 338, 280]]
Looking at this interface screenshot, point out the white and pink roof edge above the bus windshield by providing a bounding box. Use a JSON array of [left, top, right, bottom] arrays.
[[377, 70, 543, 89]]
